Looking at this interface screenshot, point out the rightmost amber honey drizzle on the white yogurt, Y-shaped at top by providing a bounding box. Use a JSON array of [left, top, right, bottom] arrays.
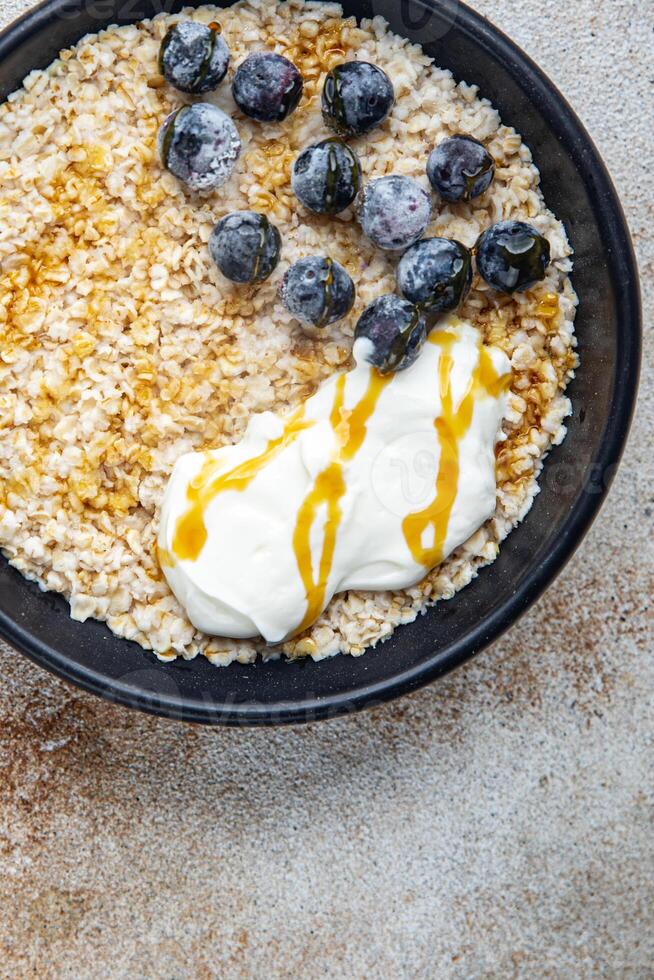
[[402, 330, 511, 568]]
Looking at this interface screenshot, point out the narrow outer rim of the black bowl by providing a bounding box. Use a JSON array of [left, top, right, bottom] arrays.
[[0, 0, 642, 726]]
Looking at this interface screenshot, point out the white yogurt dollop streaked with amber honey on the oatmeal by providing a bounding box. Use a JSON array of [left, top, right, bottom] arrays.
[[159, 318, 510, 643]]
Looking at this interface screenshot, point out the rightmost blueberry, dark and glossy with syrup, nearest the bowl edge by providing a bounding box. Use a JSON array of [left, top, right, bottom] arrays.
[[477, 221, 550, 293]]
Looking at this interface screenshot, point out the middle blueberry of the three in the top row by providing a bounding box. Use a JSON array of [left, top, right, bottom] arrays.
[[232, 51, 304, 122]]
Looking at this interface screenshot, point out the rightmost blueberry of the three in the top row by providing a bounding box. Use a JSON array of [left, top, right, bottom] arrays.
[[322, 61, 395, 136]]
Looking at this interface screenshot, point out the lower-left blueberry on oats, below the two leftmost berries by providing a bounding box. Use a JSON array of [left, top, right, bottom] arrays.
[[209, 211, 282, 283]]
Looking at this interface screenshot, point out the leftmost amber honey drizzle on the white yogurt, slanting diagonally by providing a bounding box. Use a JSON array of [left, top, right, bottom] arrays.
[[172, 405, 314, 561]]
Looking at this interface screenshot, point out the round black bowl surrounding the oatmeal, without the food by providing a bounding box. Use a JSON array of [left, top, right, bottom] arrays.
[[0, 0, 641, 725]]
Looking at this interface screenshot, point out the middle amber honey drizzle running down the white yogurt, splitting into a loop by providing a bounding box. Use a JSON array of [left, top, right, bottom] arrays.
[[293, 369, 393, 634]]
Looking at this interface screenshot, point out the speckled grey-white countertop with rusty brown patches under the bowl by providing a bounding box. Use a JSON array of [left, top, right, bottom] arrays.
[[0, 0, 654, 980]]
